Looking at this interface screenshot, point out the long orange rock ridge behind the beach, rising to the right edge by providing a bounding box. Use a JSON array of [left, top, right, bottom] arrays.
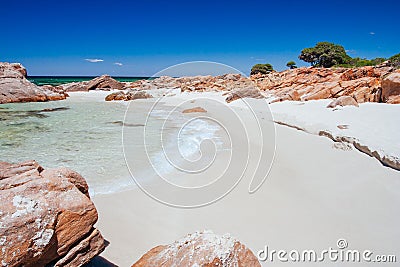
[[107, 64, 400, 104]]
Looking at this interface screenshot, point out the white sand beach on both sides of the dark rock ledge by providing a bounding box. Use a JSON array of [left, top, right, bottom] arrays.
[[92, 93, 400, 266]]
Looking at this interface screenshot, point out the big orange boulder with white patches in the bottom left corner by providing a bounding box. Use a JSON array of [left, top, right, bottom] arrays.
[[0, 161, 105, 267]]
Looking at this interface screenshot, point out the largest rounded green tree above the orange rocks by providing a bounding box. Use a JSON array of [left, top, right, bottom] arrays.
[[299, 42, 351, 68]]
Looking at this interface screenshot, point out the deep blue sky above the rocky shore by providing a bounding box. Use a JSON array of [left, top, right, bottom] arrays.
[[0, 0, 400, 76]]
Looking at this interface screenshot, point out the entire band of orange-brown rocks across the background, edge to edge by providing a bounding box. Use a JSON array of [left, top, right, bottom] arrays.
[[0, 63, 400, 104]]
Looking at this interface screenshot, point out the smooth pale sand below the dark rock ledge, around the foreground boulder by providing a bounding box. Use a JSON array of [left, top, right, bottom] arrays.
[[83, 93, 400, 266]]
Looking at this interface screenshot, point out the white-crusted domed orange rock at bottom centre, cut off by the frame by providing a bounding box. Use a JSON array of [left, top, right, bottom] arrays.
[[132, 231, 261, 267]]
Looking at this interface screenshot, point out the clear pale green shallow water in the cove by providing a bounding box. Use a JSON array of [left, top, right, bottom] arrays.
[[0, 96, 225, 195]]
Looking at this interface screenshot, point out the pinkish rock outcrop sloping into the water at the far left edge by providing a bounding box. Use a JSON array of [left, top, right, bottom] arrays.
[[0, 62, 67, 104]]
